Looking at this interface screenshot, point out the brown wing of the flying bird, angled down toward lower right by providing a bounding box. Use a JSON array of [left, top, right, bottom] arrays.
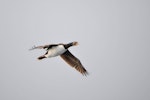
[[60, 50, 88, 75]]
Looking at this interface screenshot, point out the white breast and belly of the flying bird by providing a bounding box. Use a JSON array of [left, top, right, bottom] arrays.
[[45, 45, 67, 57]]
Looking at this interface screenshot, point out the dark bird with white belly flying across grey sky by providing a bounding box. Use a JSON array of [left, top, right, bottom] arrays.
[[30, 42, 88, 75]]
